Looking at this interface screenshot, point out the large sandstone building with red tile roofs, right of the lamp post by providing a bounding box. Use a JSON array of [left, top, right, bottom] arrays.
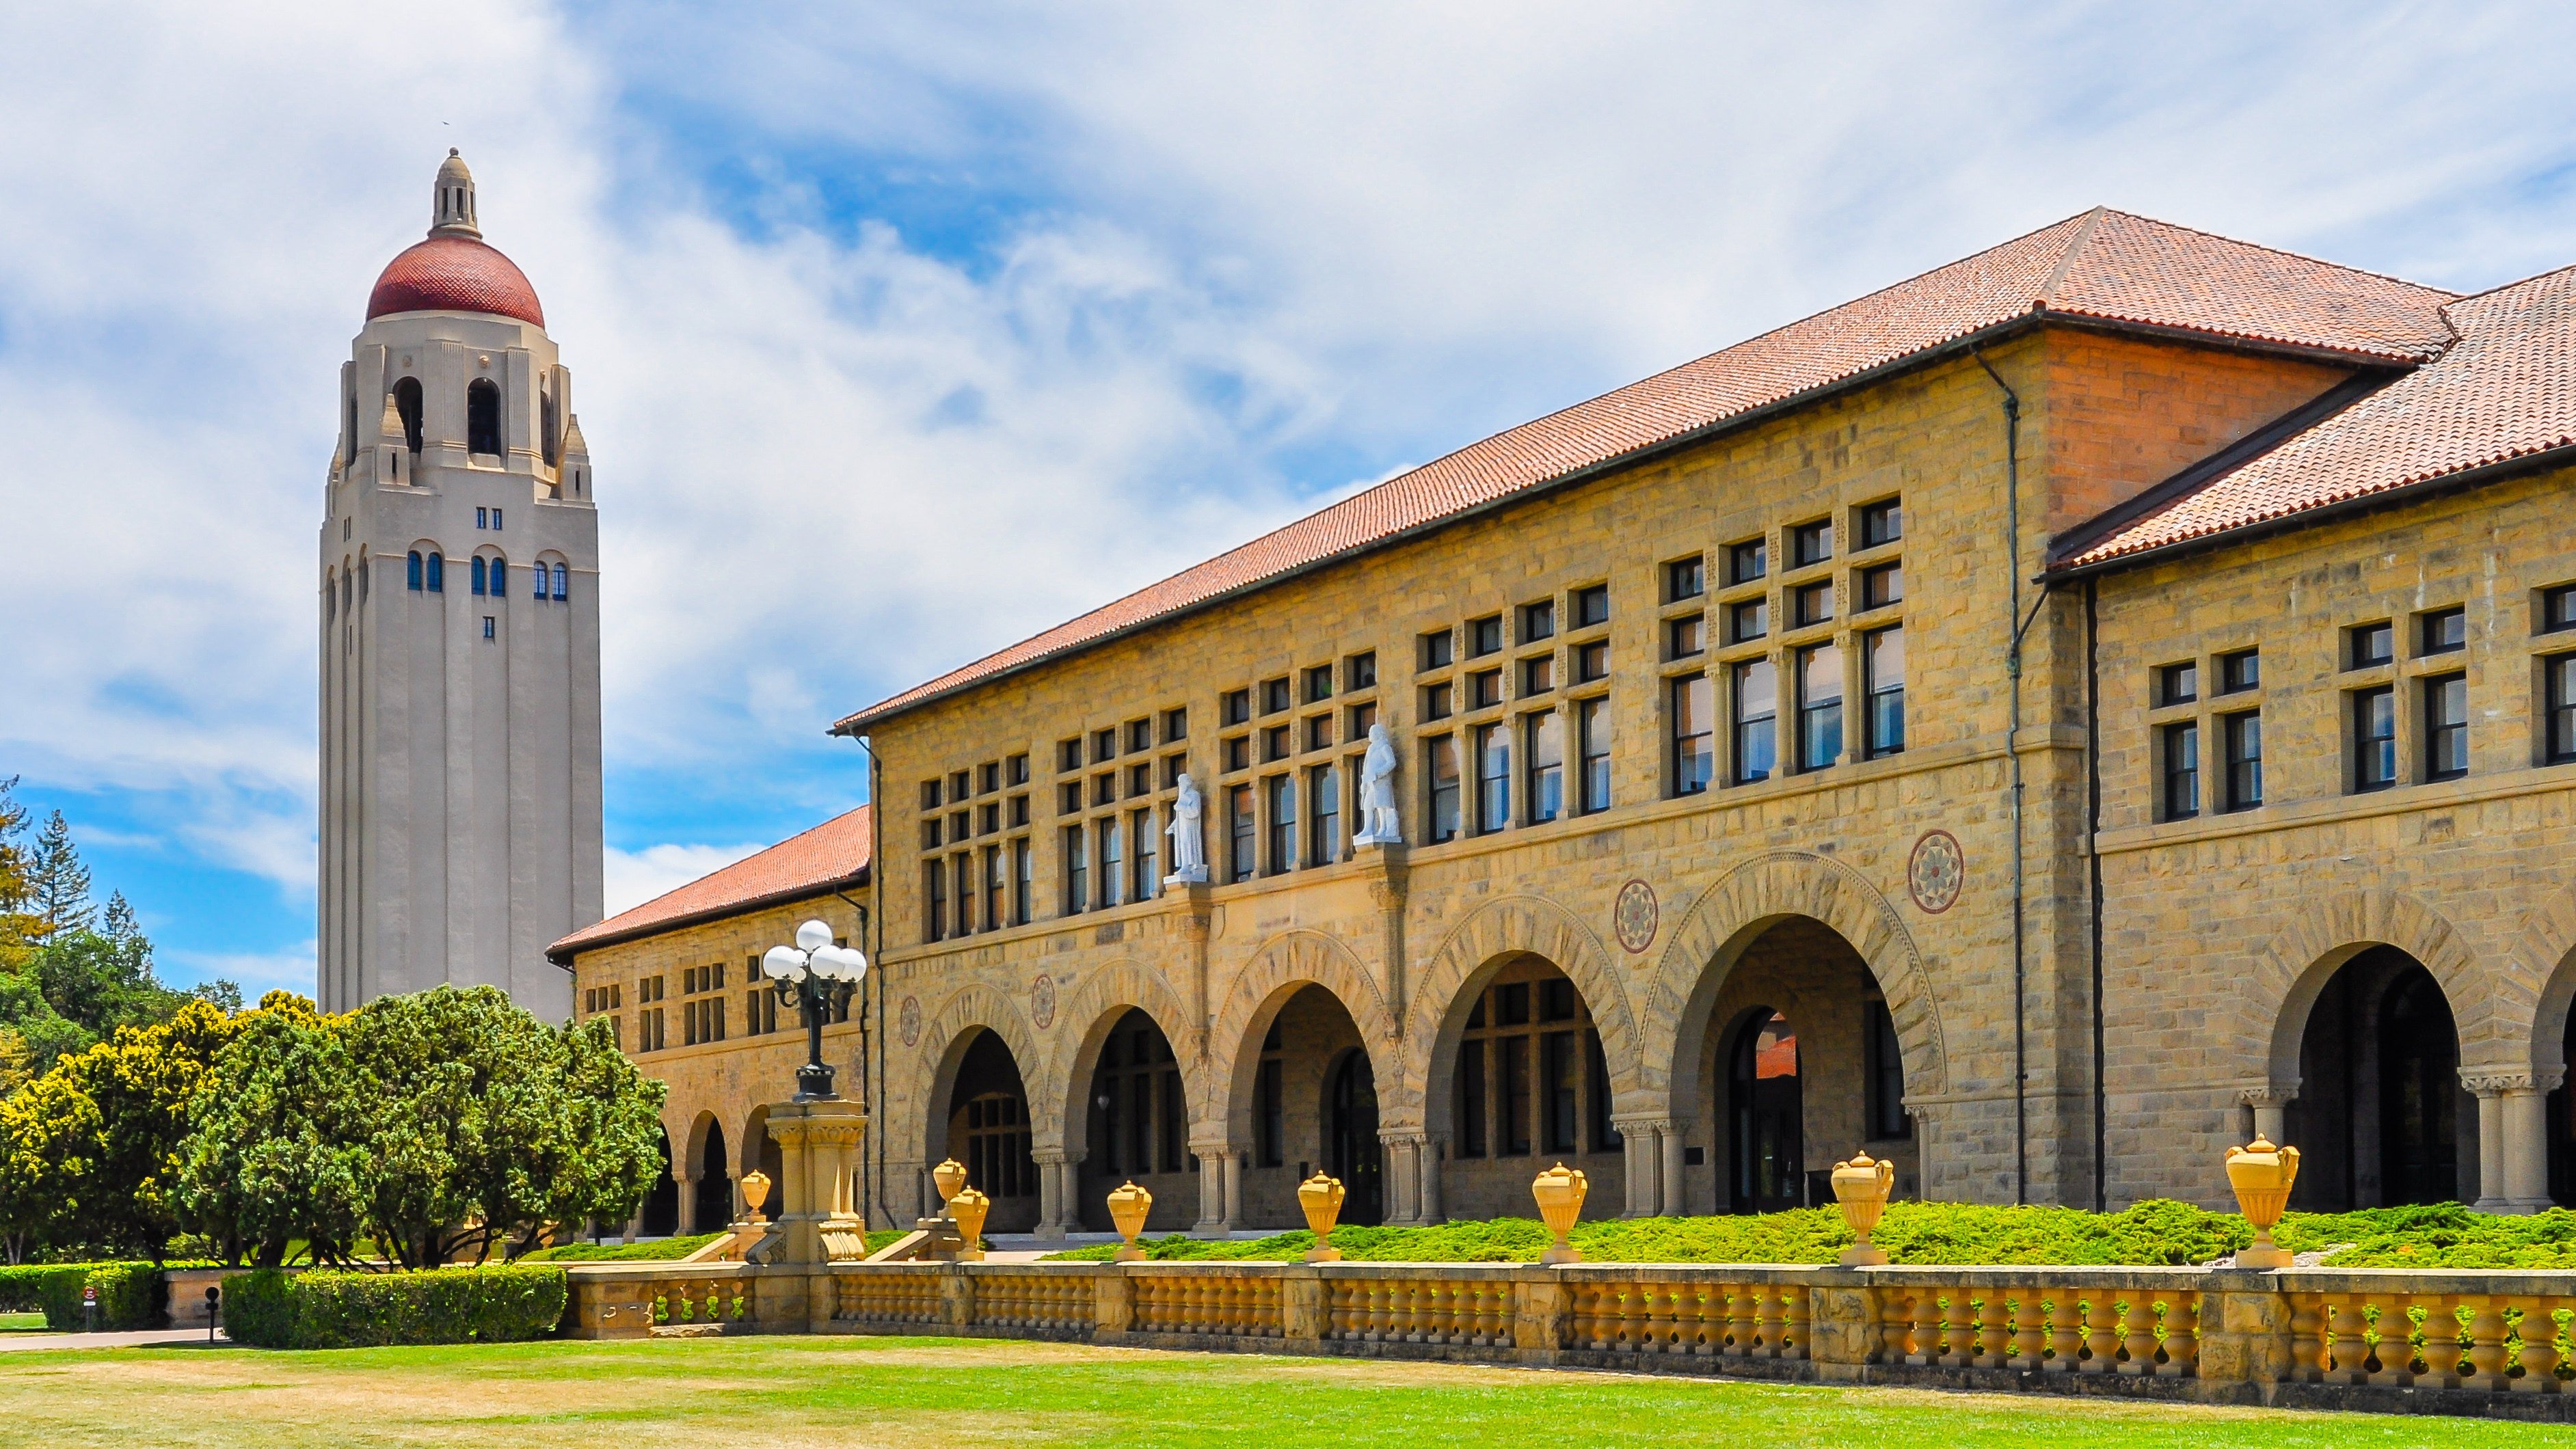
[[554, 211, 2576, 1233]]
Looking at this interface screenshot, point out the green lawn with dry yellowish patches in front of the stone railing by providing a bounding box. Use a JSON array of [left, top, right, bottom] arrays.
[[0, 1336, 2576, 1449]]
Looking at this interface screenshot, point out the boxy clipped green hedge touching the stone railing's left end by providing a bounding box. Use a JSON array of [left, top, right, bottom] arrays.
[[224, 1264, 567, 1349]]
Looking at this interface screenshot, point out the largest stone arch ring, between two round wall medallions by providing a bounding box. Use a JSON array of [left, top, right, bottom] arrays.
[[1643, 850, 1950, 1112]]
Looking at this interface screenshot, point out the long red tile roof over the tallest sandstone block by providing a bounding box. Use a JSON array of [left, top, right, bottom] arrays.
[[832, 208, 2452, 733]]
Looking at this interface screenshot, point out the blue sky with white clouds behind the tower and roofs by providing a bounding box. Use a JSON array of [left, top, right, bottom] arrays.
[[0, 0, 2576, 993]]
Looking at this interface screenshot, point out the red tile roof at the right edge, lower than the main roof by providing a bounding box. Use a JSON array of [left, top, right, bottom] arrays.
[[2058, 268, 2576, 569]]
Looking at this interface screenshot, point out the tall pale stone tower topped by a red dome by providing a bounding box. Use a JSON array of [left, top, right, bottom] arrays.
[[317, 149, 600, 1019]]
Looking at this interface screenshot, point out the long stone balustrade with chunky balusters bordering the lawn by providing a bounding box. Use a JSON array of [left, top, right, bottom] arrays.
[[567, 1261, 2576, 1421]]
